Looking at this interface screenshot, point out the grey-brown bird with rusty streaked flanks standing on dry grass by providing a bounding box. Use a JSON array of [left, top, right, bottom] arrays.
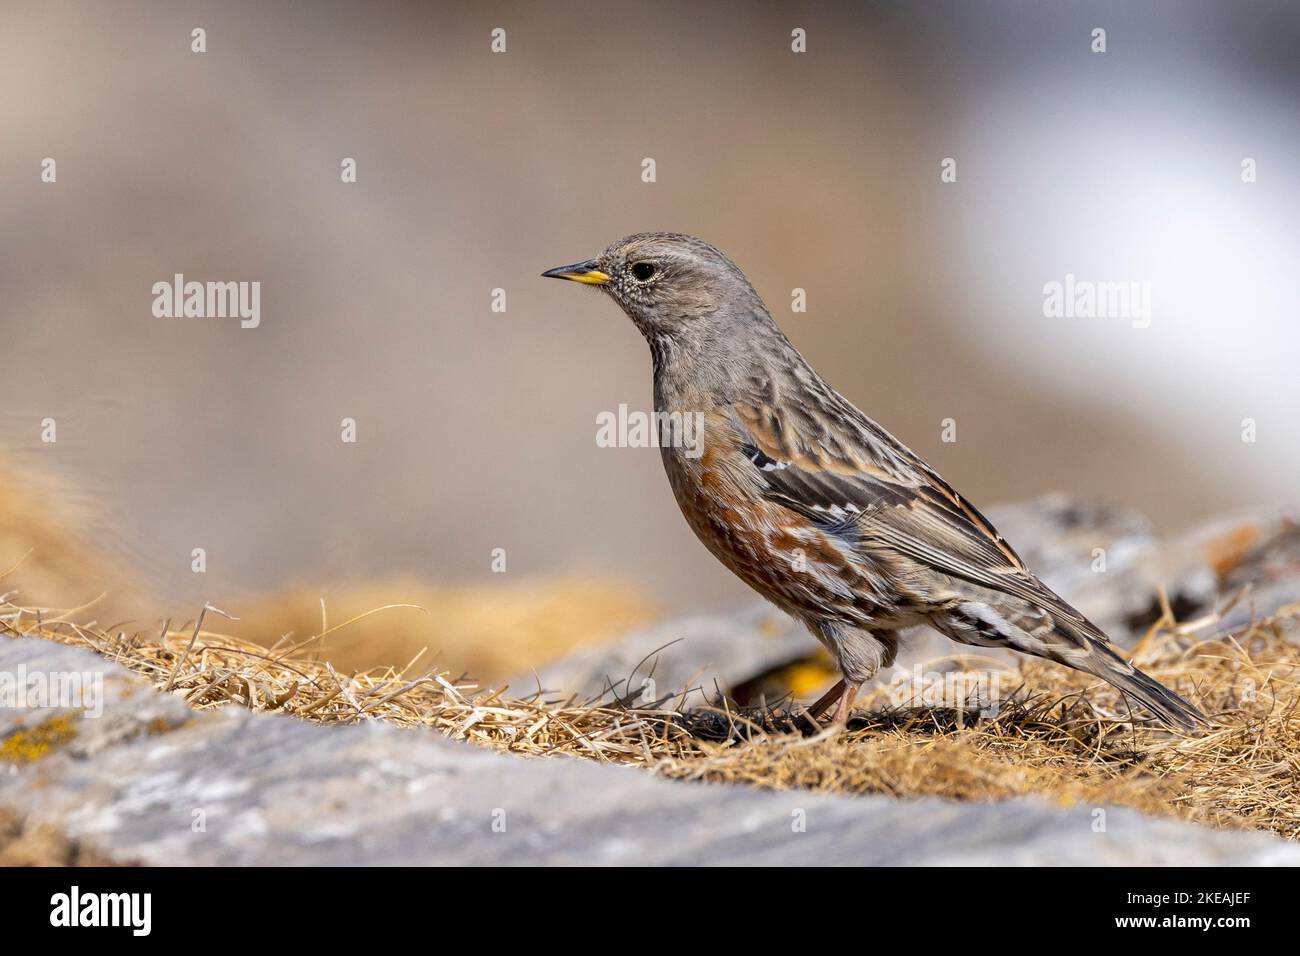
[[542, 232, 1205, 731]]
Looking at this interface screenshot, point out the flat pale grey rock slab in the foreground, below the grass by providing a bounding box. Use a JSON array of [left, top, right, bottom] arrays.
[[0, 639, 1300, 865]]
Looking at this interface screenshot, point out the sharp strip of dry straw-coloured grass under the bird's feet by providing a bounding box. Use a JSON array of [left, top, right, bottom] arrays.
[[0, 590, 1300, 839]]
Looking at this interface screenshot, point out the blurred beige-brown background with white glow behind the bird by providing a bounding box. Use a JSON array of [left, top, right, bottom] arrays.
[[0, 0, 1300, 672]]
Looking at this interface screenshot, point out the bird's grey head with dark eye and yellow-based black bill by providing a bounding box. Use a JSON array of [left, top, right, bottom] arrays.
[[542, 233, 767, 338]]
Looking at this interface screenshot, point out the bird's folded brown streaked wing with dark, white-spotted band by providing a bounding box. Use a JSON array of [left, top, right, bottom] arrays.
[[732, 397, 1105, 640]]
